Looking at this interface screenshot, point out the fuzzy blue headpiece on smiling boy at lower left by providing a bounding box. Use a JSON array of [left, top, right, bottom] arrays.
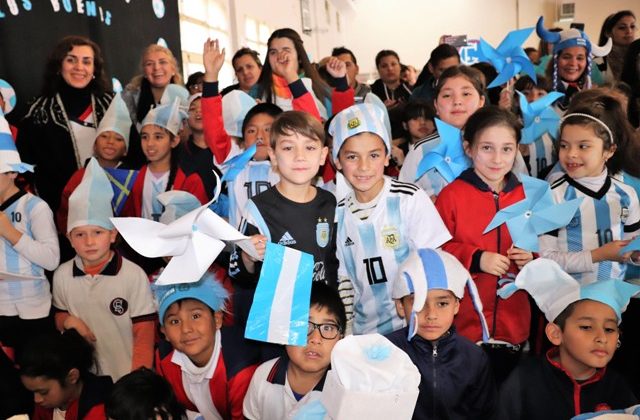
[[152, 273, 229, 325]]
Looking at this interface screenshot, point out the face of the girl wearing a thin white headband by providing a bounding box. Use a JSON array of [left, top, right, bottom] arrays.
[[558, 124, 615, 178]]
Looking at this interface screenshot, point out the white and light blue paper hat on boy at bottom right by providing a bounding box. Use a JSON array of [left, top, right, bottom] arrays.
[[498, 258, 640, 323]]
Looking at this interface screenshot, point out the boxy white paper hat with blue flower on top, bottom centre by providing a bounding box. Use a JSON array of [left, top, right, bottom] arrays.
[[321, 334, 420, 419]]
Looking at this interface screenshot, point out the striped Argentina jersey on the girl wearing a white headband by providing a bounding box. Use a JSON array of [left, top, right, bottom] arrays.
[[540, 175, 640, 284]]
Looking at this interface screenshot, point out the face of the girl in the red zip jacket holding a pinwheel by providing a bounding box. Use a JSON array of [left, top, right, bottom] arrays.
[[464, 125, 518, 191]]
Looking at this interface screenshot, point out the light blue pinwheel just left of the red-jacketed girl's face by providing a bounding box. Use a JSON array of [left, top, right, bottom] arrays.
[[416, 118, 470, 182]]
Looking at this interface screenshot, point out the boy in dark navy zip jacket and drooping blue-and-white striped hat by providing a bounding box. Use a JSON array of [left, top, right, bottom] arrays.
[[387, 249, 497, 419]]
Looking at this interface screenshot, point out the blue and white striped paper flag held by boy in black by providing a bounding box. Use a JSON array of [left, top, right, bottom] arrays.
[[245, 242, 314, 346]]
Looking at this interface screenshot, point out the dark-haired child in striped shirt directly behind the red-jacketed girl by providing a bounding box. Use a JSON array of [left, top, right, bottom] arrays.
[[398, 66, 485, 200]]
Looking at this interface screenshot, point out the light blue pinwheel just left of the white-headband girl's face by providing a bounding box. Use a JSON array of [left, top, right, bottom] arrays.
[[516, 91, 564, 144]]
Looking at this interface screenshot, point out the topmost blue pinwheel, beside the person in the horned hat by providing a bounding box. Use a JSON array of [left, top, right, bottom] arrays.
[[479, 28, 536, 88]]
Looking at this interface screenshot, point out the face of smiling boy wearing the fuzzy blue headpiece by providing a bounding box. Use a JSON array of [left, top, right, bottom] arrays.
[[162, 299, 222, 367]]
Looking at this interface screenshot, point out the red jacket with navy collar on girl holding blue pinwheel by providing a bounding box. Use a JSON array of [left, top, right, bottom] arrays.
[[436, 169, 531, 344]]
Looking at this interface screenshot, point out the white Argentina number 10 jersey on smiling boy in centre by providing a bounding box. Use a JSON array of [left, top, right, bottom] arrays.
[[336, 177, 451, 334]]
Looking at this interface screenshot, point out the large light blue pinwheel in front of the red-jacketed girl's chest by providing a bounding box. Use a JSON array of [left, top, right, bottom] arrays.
[[483, 175, 583, 251]]
